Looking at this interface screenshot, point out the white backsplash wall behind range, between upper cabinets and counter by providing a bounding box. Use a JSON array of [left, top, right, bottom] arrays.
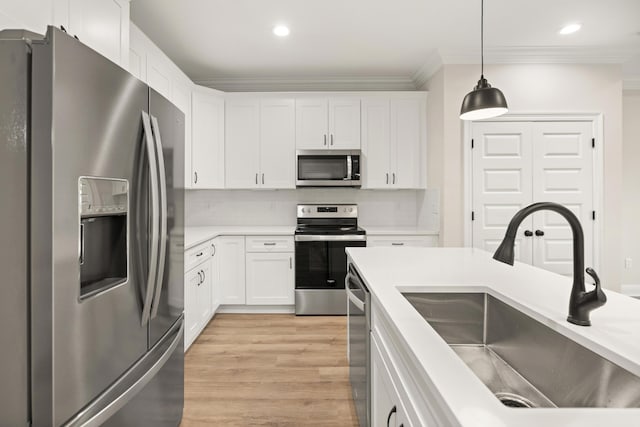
[[186, 188, 438, 229]]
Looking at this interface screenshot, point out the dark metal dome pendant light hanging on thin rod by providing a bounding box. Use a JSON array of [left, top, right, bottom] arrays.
[[460, 0, 508, 120]]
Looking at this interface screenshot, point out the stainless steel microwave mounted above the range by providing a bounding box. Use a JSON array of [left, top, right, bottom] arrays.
[[296, 150, 362, 187]]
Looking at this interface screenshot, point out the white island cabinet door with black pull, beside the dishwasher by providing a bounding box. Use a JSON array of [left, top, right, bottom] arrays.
[[371, 334, 413, 427]]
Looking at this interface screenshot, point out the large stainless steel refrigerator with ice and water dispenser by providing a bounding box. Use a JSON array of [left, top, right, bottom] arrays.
[[0, 27, 184, 427]]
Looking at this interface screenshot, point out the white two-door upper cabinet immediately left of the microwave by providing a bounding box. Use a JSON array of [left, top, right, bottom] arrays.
[[225, 97, 295, 189]]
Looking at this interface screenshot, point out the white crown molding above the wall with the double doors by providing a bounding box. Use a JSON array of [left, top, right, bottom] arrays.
[[439, 46, 637, 64]]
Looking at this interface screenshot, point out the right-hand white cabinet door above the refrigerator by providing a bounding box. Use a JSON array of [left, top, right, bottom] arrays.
[[68, 0, 129, 67]]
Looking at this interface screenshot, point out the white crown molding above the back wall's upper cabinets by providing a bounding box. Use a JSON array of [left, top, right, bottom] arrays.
[[194, 76, 416, 92]]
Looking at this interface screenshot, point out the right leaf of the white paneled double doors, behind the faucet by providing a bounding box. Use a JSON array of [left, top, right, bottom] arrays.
[[532, 122, 594, 276]]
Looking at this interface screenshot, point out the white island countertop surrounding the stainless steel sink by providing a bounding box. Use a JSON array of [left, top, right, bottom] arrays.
[[347, 247, 640, 427]]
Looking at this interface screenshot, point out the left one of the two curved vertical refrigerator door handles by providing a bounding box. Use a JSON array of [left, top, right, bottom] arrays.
[[142, 111, 160, 325]]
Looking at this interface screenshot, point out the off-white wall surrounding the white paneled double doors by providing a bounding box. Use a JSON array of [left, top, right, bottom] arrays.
[[425, 64, 622, 290]]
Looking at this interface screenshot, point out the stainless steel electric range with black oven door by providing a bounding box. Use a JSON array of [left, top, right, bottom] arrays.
[[295, 204, 367, 315]]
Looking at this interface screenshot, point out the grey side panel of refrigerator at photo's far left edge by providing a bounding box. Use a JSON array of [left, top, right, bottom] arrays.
[[0, 36, 29, 426]]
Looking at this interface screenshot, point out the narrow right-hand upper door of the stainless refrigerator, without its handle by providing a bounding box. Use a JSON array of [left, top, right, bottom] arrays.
[[149, 89, 184, 347]]
